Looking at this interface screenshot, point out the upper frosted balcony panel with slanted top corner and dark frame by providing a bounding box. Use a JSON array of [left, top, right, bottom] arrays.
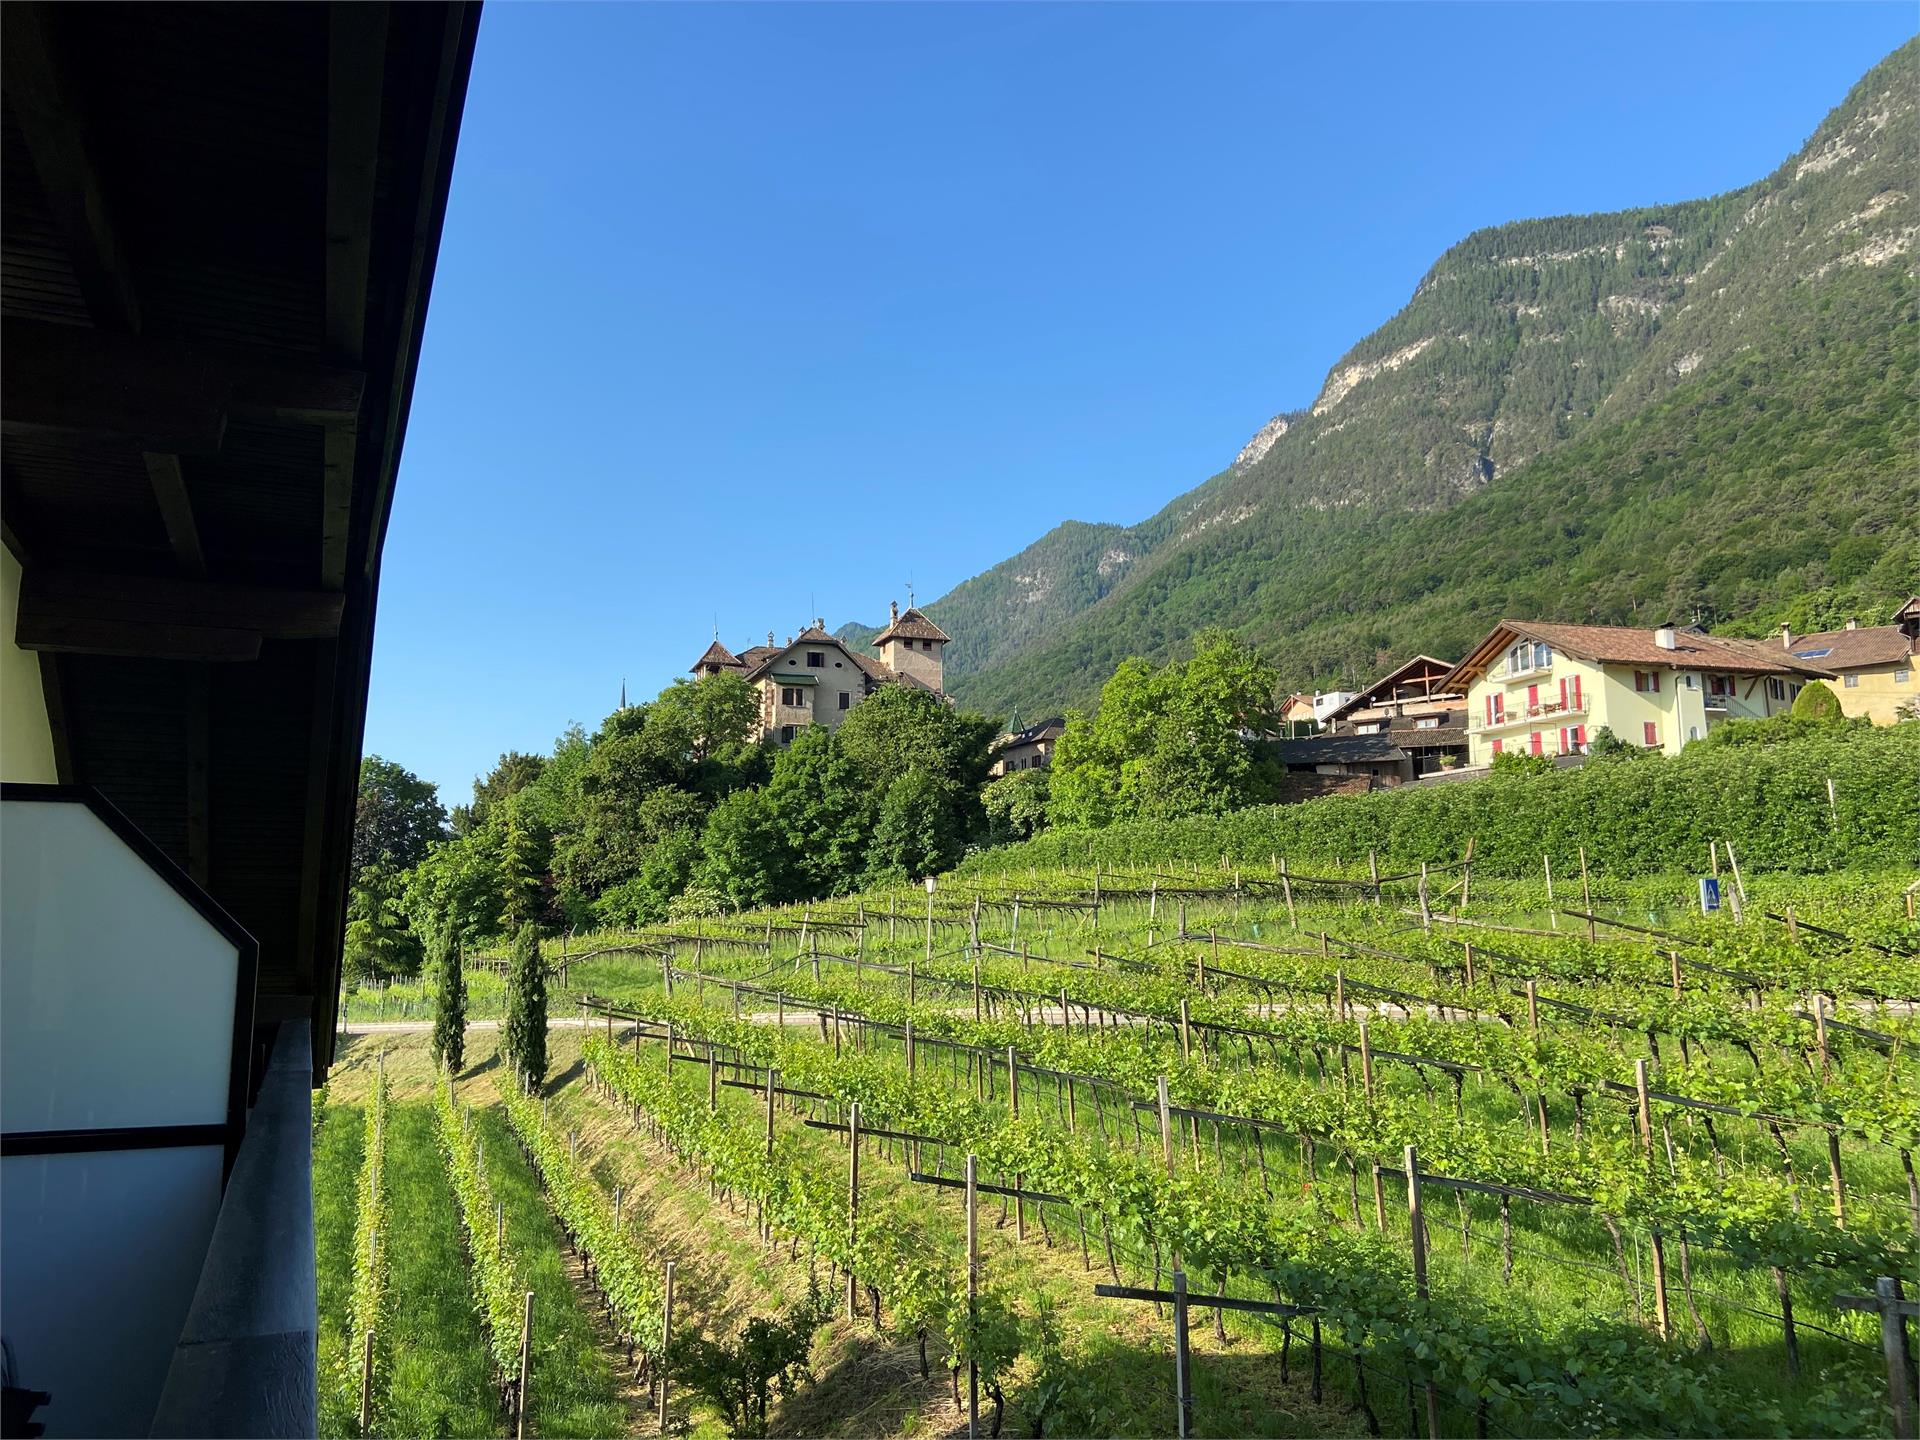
[[0, 801, 240, 1131]]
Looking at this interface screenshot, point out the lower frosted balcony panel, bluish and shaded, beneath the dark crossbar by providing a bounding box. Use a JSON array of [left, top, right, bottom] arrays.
[[0, 1144, 225, 1438]]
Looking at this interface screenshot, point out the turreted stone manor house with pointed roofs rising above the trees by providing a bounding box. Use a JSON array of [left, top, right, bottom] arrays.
[[693, 601, 950, 745]]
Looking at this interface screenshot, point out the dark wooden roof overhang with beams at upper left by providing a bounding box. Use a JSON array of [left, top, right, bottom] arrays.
[[0, 4, 480, 1073]]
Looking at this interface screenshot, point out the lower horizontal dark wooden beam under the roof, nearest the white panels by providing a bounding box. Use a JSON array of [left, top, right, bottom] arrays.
[[15, 566, 342, 660]]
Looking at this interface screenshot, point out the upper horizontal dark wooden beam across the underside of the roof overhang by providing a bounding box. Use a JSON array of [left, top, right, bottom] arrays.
[[0, 321, 367, 455]]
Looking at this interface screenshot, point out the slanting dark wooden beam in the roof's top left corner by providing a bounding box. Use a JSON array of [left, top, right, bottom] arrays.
[[0, 4, 140, 336]]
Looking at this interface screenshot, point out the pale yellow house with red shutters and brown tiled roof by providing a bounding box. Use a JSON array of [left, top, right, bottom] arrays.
[[1444, 620, 1834, 766]]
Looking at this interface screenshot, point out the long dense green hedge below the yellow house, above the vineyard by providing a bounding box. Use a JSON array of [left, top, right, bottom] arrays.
[[960, 722, 1920, 876]]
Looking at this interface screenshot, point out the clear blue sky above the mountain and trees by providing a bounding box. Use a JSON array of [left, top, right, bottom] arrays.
[[367, 0, 1914, 803]]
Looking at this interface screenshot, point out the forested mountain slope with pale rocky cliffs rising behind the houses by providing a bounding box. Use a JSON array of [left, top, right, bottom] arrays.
[[854, 42, 1920, 716]]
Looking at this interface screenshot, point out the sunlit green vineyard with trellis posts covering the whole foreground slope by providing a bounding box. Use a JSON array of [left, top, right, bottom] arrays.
[[315, 845, 1920, 1436]]
